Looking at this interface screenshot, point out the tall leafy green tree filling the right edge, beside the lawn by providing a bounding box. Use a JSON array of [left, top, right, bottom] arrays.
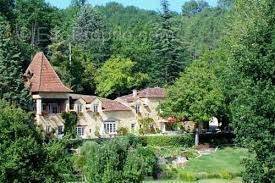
[[224, 0, 275, 182]]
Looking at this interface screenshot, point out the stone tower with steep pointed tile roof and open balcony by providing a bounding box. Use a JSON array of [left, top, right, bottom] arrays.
[[24, 52, 73, 136]]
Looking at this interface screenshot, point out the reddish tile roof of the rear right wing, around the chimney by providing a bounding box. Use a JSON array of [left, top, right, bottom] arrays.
[[118, 87, 165, 102]]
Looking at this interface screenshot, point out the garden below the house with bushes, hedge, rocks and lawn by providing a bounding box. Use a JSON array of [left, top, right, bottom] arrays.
[[74, 134, 248, 183]]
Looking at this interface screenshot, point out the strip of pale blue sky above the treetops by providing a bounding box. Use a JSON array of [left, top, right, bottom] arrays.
[[46, 0, 217, 12]]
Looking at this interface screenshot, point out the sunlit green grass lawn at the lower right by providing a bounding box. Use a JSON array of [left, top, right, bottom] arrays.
[[148, 147, 248, 183]]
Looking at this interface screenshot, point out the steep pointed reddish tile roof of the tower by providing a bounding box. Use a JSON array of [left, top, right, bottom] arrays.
[[24, 52, 72, 93]]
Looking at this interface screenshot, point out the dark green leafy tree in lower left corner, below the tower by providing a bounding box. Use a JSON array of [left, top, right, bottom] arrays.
[[0, 100, 72, 182]]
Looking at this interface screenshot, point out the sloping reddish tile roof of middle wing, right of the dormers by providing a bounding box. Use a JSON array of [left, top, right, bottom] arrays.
[[100, 98, 131, 112]]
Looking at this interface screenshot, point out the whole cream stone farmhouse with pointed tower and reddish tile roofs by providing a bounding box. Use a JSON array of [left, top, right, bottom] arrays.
[[24, 52, 167, 139]]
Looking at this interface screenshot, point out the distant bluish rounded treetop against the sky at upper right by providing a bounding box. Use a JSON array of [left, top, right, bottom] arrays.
[[182, 0, 209, 16]]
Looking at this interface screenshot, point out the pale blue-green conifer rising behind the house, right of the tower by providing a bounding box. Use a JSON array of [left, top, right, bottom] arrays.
[[73, 5, 111, 67]]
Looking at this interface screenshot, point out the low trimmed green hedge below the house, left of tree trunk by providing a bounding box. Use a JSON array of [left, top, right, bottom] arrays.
[[140, 134, 194, 147]]
